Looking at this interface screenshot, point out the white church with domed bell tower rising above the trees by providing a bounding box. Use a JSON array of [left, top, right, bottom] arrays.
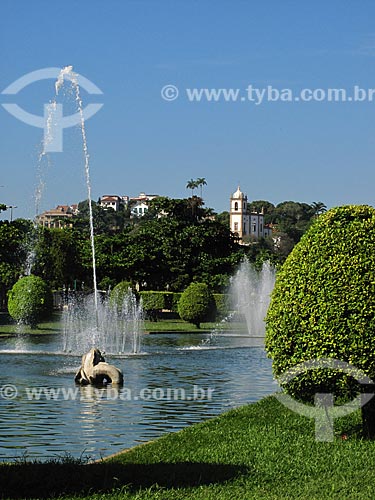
[[229, 186, 272, 241]]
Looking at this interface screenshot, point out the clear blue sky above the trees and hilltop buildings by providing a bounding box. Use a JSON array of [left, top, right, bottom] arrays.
[[0, 0, 375, 218]]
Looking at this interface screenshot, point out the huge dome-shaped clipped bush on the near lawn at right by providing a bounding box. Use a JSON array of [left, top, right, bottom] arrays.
[[265, 206, 375, 401]]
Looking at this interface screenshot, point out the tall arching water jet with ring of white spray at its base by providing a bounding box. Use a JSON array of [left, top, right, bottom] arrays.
[[43, 66, 143, 354]]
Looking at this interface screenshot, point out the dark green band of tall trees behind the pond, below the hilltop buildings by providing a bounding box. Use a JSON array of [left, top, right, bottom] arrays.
[[0, 194, 324, 307]]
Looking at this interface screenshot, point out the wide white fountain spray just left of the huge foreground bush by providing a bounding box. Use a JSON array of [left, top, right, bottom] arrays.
[[229, 260, 276, 337]]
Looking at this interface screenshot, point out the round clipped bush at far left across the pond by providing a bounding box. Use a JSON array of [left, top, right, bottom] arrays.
[[8, 275, 53, 327]]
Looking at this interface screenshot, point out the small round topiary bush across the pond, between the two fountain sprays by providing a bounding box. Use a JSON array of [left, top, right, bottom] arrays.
[[178, 283, 215, 328]]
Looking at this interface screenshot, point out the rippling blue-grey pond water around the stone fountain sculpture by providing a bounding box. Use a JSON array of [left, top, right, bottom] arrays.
[[0, 334, 278, 460]]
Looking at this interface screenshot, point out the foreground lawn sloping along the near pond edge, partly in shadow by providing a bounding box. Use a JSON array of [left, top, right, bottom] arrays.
[[0, 397, 375, 500]]
